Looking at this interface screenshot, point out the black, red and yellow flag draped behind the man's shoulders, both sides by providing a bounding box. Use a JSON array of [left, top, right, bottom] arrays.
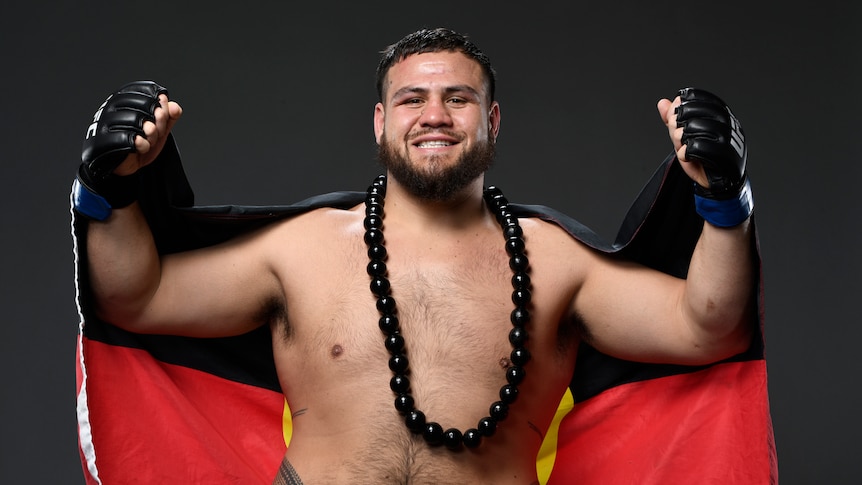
[[72, 135, 778, 485]]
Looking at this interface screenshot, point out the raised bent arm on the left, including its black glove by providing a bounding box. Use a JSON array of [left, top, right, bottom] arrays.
[[75, 82, 278, 337]]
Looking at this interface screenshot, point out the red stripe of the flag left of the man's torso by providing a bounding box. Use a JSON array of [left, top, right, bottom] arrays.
[[78, 338, 286, 484]]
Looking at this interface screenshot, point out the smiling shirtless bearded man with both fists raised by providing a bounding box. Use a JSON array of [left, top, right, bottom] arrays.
[[77, 29, 754, 485]]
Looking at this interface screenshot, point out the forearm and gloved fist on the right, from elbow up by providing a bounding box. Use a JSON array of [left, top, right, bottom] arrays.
[[657, 88, 755, 354]]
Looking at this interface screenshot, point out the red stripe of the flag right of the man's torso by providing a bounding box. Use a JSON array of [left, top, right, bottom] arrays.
[[548, 360, 778, 485]]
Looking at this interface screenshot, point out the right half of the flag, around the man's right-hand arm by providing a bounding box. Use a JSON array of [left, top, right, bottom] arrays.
[[523, 160, 778, 485]]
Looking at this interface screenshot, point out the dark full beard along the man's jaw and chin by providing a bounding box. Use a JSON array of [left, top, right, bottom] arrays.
[[377, 135, 496, 202]]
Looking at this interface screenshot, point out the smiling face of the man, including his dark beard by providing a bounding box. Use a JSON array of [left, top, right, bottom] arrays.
[[374, 52, 500, 200]]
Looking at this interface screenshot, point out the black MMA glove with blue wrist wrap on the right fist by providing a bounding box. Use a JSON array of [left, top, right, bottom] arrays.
[[676, 88, 754, 227]]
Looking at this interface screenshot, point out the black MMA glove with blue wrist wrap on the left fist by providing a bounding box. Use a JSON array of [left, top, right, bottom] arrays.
[[73, 81, 168, 221]]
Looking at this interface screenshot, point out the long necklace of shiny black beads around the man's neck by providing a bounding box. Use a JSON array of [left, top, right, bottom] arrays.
[[364, 175, 531, 451]]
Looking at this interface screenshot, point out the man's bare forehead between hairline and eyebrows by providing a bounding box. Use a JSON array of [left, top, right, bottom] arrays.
[[386, 52, 487, 99]]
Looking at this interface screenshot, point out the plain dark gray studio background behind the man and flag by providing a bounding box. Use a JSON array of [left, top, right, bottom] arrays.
[[0, 0, 862, 485]]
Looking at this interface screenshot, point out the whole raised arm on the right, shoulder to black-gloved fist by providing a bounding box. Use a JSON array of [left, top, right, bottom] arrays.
[[574, 88, 755, 364]]
